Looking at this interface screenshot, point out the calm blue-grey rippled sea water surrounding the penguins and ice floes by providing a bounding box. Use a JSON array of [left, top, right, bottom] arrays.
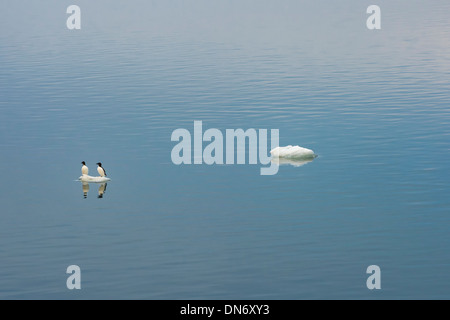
[[0, 0, 450, 300]]
